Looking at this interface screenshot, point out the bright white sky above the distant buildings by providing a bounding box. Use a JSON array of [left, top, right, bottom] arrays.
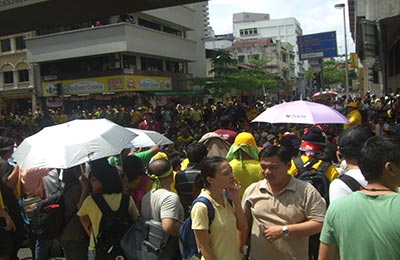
[[208, 0, 355, 55]]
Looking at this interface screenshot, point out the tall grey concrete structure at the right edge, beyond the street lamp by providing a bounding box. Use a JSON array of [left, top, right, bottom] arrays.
[[347, 0, 400, 96]]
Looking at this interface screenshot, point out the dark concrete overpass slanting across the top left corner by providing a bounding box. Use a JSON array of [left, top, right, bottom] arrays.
[[0, 0, 204, 36]]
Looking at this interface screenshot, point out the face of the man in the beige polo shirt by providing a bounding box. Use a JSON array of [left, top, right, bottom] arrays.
[[260, 155, 291, 185]]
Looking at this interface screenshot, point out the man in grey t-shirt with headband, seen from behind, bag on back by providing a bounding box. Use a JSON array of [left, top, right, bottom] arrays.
[[141, 158, 184, 240]]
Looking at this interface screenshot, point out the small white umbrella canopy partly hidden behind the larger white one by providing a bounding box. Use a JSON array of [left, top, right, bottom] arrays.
[[126, 127, 174, 148]]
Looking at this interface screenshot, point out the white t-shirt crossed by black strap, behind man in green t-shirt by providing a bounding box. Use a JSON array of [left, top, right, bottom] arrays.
[[329, 169, 368, 202]]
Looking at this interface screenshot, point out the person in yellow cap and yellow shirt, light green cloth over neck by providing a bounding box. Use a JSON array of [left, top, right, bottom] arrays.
[[226, 132, 264, 197]]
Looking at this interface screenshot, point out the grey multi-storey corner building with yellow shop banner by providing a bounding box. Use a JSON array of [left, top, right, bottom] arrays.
[[26, 3, 208, 109]]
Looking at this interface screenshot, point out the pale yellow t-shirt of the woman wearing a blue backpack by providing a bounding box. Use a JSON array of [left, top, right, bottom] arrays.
[[190, 190, 242, 260]]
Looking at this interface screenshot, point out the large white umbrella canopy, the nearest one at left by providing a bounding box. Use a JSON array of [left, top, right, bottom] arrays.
[[12, 119, 137, 169]]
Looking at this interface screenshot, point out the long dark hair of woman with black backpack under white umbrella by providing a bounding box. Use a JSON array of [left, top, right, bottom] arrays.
[[91, 159, 122, 194]]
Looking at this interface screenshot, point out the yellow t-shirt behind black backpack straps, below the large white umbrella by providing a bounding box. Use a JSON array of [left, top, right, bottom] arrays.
[[77, 193, 139, 250]]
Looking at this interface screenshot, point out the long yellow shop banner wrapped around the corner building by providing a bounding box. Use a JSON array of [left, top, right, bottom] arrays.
[[42, 75, 172, 97]]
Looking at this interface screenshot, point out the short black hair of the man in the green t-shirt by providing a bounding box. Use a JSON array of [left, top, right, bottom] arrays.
[[358, 135, 400, 182]]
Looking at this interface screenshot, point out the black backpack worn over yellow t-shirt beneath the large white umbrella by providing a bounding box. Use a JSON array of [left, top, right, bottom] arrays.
[[93, 194, 131, 260]]
